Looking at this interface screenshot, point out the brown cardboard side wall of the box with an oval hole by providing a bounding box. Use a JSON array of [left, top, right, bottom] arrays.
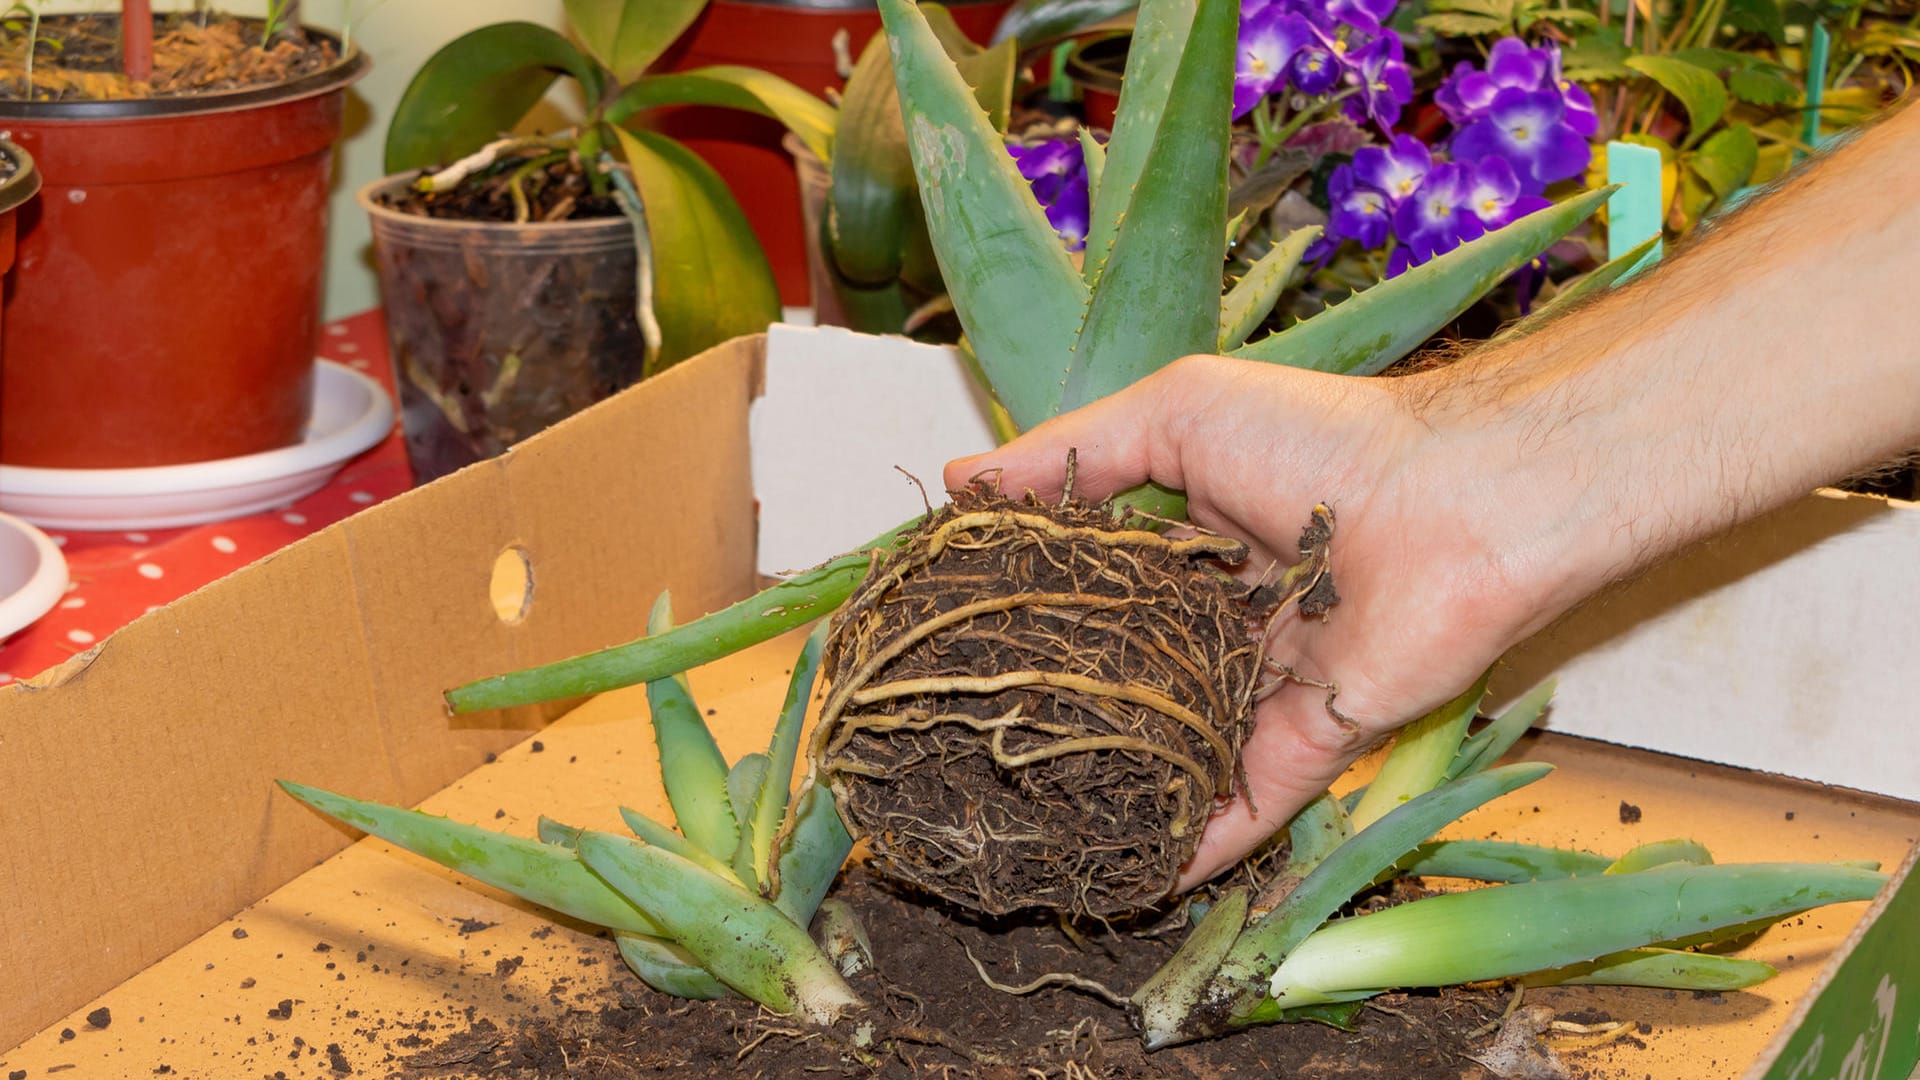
[[0, 336, 766, 1045]]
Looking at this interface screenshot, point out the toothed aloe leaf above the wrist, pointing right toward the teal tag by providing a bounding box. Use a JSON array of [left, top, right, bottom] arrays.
[[1231, 188, 1613, 375]]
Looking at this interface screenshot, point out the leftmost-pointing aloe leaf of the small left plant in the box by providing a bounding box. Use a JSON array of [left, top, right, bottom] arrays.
[[276, 780, 662, 938]]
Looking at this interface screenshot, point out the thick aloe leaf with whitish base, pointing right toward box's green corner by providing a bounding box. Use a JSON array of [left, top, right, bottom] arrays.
[[1271, 857, 1885, 1005]]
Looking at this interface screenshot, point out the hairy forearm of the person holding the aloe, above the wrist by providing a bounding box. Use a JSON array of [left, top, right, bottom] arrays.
[[1407, 99, 1920, 622]]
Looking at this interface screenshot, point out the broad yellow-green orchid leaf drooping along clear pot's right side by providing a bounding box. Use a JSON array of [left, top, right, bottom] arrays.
[[612, 127, 780, 375]]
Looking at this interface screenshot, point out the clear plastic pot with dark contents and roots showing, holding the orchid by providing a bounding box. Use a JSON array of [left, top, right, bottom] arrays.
[[357, 173, 645, 484]]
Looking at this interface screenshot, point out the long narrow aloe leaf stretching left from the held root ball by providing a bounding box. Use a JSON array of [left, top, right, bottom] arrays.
[[447, 517, 922, 713]]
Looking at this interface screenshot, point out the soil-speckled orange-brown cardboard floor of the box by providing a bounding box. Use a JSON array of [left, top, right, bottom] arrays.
[[0, 634, 1920, 1080]]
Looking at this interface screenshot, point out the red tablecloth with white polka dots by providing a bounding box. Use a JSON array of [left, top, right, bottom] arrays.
[[0, 309, 413, 684]]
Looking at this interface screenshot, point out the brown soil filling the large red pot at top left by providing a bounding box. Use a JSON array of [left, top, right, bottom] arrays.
[[0, 12, 340, 102]]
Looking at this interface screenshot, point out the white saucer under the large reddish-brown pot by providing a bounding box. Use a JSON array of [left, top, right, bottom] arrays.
[[0, 359, 394, 530]]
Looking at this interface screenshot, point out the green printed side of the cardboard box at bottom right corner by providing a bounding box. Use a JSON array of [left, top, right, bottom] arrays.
[[1766, 847, 1920, 1080]]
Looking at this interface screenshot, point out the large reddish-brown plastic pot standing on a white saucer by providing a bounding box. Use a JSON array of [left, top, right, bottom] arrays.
[[0, 38, 367, 469]]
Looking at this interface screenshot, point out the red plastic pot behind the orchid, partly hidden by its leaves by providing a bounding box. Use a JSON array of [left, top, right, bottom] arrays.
[[653, 0, 1012, 304]]
